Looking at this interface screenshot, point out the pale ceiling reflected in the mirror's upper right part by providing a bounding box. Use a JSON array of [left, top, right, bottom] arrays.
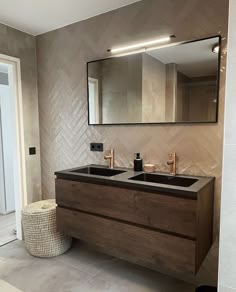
[[147, 37, 219, 77]]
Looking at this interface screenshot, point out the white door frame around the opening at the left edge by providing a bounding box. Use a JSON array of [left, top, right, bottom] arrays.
[[0, 54, 27, 240]]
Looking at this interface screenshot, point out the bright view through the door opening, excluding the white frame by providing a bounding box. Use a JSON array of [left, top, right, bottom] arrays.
[[0, 63, 16, 246]]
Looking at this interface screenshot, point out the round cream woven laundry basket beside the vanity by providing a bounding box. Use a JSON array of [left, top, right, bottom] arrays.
[[22, 200, 72, 258]]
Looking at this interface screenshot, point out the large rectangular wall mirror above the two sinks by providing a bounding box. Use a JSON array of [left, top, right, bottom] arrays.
[[87, 36, 220, 125]]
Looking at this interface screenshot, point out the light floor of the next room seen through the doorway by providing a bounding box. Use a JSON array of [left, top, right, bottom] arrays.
[[0, 213, 16, 246]]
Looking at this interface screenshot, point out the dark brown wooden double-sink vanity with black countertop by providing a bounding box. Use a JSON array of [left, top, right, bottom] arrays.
[[55, 165, 214, 275]]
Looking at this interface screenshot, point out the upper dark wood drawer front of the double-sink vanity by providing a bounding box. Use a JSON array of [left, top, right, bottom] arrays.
[[56, 179, 197, 239]]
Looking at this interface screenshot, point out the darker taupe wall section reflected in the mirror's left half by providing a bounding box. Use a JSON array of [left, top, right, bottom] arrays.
[[102, 55, 142, 124]]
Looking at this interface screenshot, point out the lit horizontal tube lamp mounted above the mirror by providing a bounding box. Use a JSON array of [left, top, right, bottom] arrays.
[[107, 35, 175, 54]]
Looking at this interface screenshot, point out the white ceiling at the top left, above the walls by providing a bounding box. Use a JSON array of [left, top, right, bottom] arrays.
[[0, 0, 141, 35]]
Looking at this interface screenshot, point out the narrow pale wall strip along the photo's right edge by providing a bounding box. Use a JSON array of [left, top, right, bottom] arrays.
[[219, 0, 236, 292]]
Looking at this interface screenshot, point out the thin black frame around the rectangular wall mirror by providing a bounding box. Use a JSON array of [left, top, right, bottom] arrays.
[[86, 35, 222, 126]]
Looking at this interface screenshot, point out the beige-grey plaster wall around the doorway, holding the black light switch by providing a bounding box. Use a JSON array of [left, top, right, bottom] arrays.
[[0, 24, 41, 203]]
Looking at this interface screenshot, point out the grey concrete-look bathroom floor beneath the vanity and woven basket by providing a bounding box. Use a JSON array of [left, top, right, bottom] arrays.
[[0, 241, 195, 292]]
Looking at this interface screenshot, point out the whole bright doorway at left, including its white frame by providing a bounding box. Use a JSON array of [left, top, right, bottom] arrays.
[[0, 54, 27, 246]]
